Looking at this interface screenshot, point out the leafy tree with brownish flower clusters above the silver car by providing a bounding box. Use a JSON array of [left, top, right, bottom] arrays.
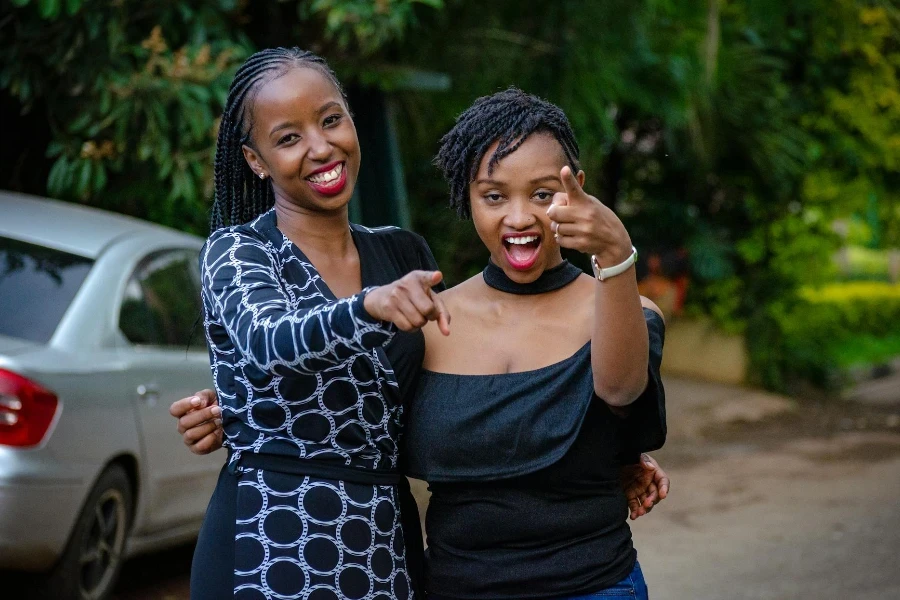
[[0, 0, 440, 232]]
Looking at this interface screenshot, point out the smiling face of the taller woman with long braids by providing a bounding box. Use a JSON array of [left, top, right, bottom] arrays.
[[243, 67, 360, 212]]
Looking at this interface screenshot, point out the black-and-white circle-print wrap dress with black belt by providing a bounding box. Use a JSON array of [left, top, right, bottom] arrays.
[[191, 210, 436, 600]]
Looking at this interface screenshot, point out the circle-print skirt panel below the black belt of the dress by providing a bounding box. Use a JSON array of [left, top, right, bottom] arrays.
[[234, 469, 412, 600]]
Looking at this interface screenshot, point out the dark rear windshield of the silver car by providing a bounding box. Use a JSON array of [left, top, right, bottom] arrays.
[[0, 236, 94, 343]]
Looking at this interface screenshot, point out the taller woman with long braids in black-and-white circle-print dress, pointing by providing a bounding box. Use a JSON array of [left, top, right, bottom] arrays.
[[191, 48, 449, 600]]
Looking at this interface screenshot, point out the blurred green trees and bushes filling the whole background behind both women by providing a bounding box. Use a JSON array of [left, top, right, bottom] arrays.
[[0, 0, 900, 391]]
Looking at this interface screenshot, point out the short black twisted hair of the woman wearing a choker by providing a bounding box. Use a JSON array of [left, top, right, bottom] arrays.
[[434, 87, 580, 219]]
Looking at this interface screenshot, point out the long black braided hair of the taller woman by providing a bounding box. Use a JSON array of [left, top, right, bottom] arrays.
[[209, 47, 347, 231]]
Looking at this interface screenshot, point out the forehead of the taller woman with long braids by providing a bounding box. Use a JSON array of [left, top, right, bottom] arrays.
[[253, 67, 343, 120]]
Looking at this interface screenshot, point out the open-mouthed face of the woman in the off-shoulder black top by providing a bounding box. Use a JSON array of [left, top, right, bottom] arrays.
[[469, 133, 584, 283]]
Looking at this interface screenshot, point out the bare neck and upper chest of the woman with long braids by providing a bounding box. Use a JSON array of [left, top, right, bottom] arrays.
[[275, 198, 354, 257]]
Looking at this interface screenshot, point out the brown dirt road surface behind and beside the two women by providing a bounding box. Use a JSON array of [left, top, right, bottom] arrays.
[[107, 379, 900, 600]]
